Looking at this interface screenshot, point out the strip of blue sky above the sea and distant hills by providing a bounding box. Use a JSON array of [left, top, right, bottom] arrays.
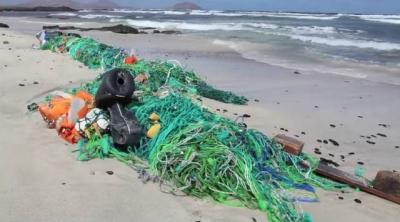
[[0, 0, 400, 14]]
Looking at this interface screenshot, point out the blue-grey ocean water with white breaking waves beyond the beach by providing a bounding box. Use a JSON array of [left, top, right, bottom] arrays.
[[3, 10, 400, 84]]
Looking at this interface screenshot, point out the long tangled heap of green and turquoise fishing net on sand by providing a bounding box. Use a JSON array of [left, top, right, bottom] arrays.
[[42, 33, 342, 221]]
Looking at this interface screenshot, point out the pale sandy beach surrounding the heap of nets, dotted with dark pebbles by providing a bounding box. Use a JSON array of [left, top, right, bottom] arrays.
[[0, 17, 400, 222]]
